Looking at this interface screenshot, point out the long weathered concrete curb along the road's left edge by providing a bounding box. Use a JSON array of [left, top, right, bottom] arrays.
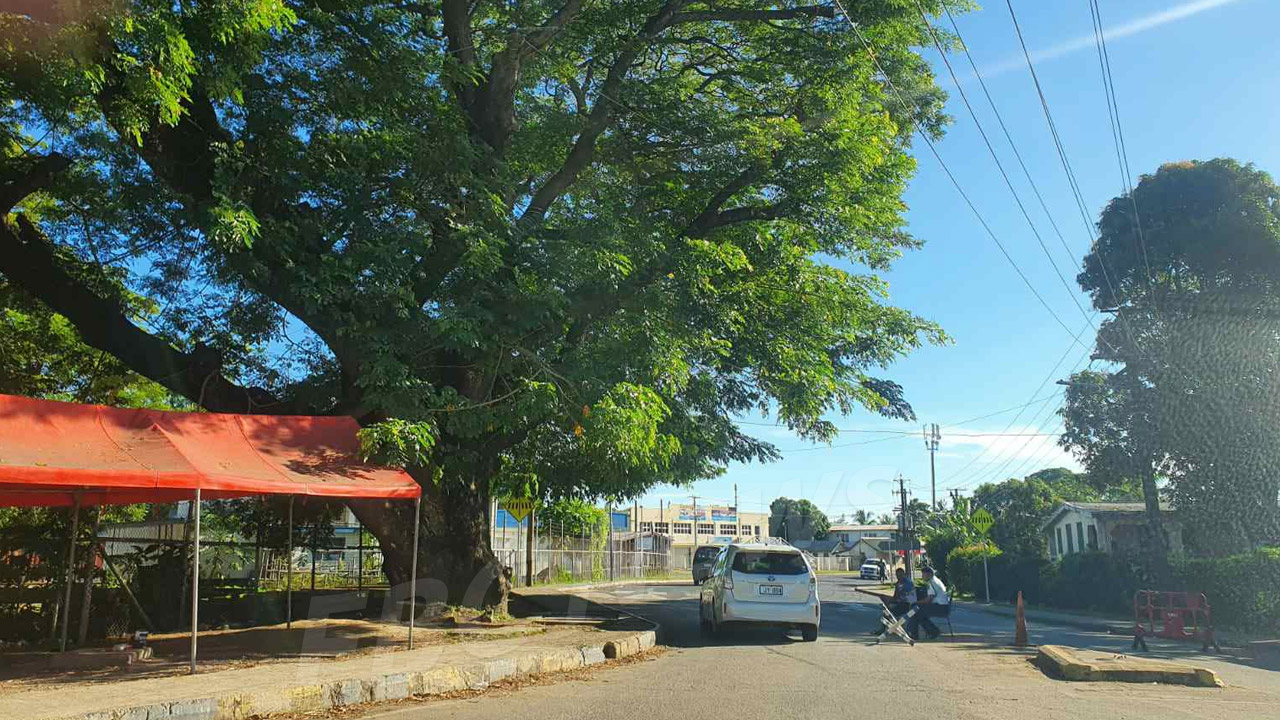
[[60, 630, 657, 720]]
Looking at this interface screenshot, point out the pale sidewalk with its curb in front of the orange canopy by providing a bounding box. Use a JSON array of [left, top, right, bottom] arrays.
[[0, 626, 654, 720]]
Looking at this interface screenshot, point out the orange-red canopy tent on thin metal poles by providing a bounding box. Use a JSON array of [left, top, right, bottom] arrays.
[[0, 395, 422, 671]]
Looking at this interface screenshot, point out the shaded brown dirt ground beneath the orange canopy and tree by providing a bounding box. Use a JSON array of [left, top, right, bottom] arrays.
[[0, 619, 550, 696]]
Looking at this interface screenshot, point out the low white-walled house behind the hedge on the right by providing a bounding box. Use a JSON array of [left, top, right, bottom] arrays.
[[1041, 502, 1183, 560]]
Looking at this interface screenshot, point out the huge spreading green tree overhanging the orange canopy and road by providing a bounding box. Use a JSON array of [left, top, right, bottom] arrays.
[[0, 0, 945, 603]]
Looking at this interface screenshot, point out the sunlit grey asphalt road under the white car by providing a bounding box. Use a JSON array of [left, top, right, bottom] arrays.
[[363, 575, 1280, 720]]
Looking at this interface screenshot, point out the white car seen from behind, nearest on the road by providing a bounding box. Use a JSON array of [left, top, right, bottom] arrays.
[[699, 542, 822, 642]]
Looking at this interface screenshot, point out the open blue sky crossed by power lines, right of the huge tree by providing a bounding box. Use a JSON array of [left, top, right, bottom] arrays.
[[641, 0, 1280, 518]]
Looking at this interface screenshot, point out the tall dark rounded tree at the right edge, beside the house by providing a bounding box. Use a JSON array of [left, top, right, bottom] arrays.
[[1062, 159, 1280, 552]]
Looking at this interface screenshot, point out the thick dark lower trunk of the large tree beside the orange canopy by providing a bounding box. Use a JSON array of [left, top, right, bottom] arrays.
[[349, 471, 509, 610]]
